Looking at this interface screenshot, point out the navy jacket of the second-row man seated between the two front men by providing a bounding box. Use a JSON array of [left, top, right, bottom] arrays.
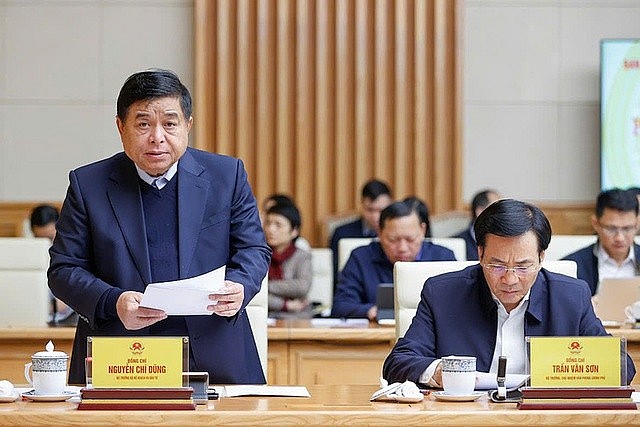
[[331, 241, 456, 317]]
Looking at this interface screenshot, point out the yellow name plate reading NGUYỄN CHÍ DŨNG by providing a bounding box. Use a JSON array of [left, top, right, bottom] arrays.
[[86, 337, 189, 388]]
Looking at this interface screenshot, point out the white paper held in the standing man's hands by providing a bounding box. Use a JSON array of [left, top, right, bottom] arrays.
[[140, 265, 226, 316]]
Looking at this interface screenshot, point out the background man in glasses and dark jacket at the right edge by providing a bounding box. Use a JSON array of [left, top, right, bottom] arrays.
[[564, 188, 640, 295]]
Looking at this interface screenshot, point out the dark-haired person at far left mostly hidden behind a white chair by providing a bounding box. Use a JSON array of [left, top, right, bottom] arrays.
[[29, 205, 78, 326]]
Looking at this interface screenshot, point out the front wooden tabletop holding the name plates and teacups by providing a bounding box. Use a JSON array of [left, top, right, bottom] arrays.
[[0, 385, 640, 427]]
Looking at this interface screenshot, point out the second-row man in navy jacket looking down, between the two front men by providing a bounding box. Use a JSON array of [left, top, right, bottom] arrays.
[[331, 201, 456, 320]]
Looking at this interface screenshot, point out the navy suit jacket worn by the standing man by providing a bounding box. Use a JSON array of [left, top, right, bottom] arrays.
[[48, 148, 270, 384]]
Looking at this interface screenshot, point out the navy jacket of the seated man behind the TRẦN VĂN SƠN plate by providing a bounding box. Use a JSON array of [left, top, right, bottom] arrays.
[[383, 265, 635, 383]]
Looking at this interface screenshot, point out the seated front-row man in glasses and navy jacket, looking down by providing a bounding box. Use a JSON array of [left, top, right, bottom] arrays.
[[383, 199, 635, 387]]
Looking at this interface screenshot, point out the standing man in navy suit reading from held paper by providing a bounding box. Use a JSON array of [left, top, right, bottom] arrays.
[[48, 70, 270, 384]]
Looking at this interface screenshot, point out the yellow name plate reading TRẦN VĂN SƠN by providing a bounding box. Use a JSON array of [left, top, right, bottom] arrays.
[[527, 336, 627, 388]]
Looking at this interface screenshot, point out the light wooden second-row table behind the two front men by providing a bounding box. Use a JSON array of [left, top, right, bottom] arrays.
[[0, 320, 640, 386]]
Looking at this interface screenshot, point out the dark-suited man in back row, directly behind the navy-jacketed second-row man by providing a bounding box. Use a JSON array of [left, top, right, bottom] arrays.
[[329, 179, 393, 293]]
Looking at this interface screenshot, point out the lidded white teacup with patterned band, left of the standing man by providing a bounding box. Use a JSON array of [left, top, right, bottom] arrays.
[[24, 341, 69, 396]]
